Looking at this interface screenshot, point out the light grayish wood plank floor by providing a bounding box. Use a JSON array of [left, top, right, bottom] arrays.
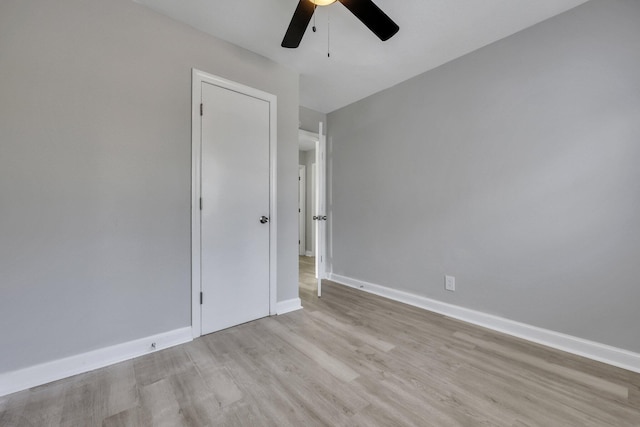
[[0, 258, 640, 427]]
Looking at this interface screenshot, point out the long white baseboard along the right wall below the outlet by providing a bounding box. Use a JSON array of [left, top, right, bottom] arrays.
[[329, 273, 640, 373]]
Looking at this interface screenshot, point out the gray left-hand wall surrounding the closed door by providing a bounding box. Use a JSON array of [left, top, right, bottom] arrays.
[[0, 0, 298, 372]]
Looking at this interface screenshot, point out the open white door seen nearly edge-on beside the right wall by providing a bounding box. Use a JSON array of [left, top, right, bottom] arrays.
[[314, 123, 327, 296]]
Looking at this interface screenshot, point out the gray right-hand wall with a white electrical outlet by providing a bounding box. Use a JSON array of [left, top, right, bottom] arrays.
[[328, 0, 640, 352]]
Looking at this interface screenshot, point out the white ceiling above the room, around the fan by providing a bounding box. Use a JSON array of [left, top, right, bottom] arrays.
[[134, 0, 587, 113]]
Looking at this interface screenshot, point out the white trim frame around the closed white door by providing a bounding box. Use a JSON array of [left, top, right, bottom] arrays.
[[191, 68, 278, 338]]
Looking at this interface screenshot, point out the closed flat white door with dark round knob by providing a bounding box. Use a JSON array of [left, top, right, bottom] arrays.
[[201, 82, 270, 334]]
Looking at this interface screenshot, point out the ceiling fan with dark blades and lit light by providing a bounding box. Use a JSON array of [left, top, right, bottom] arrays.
[[282, 0, 400, 48]]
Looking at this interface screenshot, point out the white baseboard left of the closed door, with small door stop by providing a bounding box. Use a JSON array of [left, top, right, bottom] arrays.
[[0, 326, 193, 396]]
